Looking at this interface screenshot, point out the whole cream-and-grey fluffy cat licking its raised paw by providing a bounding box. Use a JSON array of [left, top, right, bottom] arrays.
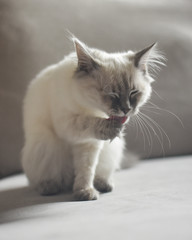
[[22, 37, 164, 201]]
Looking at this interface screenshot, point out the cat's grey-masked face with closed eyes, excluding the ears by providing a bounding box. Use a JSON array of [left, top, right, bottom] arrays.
[[95, 59, 151, 116]]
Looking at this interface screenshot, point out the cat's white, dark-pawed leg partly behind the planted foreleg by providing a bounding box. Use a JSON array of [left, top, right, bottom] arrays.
[[94, 137, 124, 193]]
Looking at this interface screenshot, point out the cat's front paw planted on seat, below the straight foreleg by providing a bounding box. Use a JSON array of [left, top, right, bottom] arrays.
[[73, 188, 99, 201]]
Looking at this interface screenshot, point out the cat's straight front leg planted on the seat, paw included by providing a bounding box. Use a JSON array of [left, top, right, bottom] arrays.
[[73, 141, 103, 201]]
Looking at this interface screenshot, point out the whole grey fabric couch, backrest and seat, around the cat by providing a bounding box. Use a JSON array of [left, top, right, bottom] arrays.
[[0, 0, 192, 240]]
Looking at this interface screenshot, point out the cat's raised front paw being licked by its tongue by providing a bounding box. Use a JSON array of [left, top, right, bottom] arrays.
[[98, 119, 123, 140]]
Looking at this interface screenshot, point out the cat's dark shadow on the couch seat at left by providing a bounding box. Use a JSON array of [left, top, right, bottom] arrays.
[[0, 186, 73, 224]]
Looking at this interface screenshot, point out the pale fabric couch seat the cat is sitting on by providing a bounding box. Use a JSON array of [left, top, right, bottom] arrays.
[[0, 156, 192, 240]]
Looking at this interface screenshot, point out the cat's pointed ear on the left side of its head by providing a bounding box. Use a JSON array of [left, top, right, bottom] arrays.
[[73, 38, 98, 73]]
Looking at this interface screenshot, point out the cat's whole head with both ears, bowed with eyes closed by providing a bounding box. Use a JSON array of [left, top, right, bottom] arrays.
[[73, 38, 162, 117]]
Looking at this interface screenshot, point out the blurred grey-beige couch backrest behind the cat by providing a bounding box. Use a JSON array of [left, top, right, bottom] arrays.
[[0, 0, 192, 177]]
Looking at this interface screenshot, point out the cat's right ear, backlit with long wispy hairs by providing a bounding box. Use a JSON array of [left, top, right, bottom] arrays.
[[134, 43, 157, 72]]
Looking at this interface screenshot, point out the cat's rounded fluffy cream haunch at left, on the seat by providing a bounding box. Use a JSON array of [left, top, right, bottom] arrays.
[[22, 129, 73, 195]]
